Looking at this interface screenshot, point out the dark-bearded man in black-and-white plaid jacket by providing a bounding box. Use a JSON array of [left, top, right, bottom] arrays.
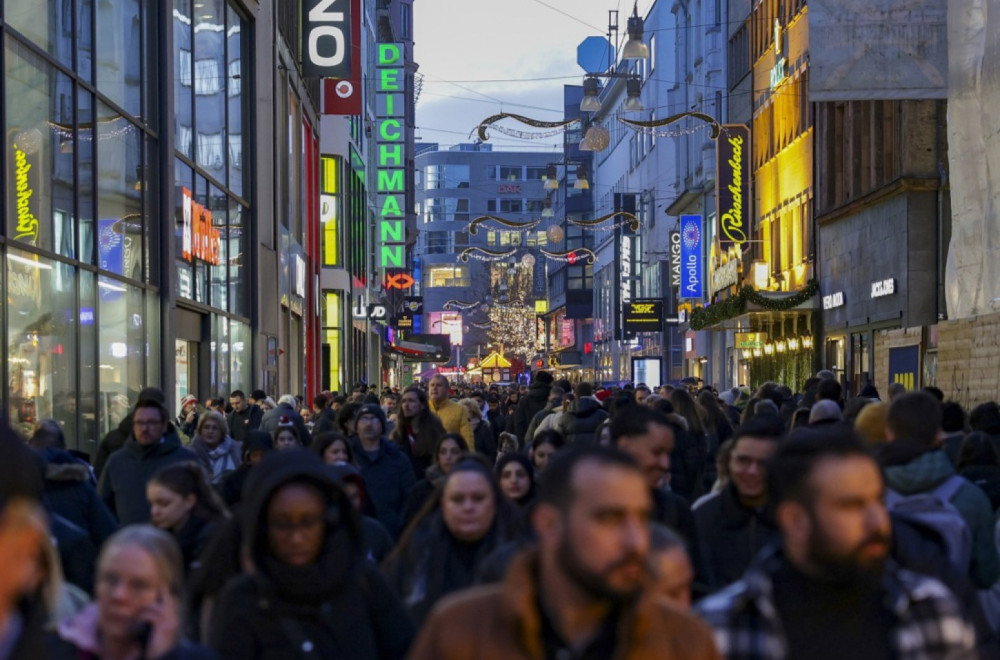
[[698, 429, 977, 660]]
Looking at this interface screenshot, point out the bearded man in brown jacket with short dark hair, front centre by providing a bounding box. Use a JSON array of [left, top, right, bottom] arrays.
[[410, 446, 718, 660]]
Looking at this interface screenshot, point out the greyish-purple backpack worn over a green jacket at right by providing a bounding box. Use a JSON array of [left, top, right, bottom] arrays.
[[885, 474, 972, 573]]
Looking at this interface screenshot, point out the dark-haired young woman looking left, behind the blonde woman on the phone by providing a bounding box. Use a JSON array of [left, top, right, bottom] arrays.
[[146, 461, 229, 573]]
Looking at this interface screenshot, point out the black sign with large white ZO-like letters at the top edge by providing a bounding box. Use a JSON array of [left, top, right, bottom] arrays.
[[302, 0, 352, 78]]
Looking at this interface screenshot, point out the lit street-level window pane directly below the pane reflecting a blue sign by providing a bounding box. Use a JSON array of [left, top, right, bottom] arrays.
[[97, 275, 146, 416]]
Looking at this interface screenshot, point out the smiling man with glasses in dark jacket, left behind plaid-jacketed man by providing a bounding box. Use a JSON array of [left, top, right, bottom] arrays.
[[694, 416, 784, 591]]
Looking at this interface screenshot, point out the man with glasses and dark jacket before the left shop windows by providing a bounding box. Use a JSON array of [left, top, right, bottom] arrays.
[[97, 399, 197, 527]]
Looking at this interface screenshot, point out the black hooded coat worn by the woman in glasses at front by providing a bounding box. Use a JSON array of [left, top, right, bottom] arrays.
[[208, 451, 414, 660]]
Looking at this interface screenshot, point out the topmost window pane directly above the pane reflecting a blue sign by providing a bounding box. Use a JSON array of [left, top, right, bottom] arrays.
[[97, 0, 144, 117]]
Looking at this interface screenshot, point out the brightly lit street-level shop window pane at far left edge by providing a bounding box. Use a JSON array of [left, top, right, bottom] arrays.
[[6, 247, 77, 444]]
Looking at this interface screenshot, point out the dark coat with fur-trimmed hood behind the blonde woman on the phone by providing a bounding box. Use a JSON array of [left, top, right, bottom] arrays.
[[41, 449, 116, 548]]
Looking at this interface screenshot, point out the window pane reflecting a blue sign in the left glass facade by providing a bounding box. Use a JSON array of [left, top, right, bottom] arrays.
[[97, 103, 146, 280]]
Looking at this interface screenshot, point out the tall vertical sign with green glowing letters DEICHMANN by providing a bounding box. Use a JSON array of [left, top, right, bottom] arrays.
[[375, 44, 406, 268]]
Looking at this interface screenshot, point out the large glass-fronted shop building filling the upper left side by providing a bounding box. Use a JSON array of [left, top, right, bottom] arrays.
[[0, 0, 318, 451]]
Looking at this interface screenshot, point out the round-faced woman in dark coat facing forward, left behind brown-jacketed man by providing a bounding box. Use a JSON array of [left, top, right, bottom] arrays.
[[385, 456, 519, 625]]
